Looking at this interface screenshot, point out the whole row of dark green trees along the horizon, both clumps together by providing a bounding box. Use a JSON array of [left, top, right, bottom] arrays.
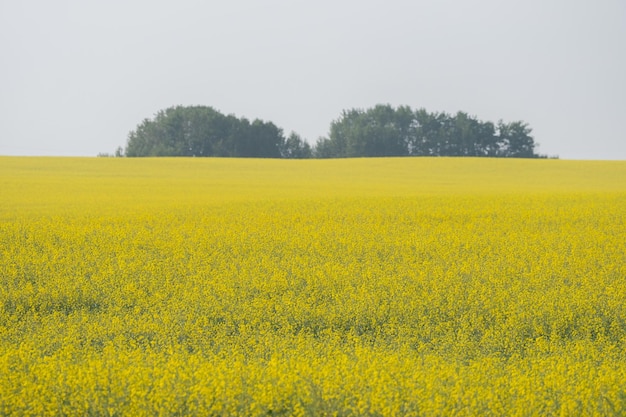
[[116, 104, 544, 158]]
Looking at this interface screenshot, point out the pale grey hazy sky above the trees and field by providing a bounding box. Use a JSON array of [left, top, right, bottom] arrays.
[[0, 0, 626, 160]]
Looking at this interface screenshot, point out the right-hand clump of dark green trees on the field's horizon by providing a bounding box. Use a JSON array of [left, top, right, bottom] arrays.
[[316, 104, 539, 158]]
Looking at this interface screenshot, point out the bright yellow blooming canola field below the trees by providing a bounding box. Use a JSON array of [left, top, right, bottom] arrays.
[[0, 158, 626, 416]]
